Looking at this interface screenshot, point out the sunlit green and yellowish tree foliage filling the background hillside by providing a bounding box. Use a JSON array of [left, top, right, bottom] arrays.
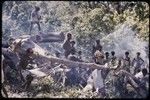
[[3, 1, 149, 44]]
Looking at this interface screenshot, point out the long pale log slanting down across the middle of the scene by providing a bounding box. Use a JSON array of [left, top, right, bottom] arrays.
[[13, 37, 112, 70]]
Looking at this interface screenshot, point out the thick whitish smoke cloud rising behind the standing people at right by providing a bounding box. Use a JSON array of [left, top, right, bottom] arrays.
[[101, 23, 149, 63]]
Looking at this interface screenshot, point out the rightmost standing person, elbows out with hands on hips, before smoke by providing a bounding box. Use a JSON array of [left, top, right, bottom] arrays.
[[132, 52, 144, 75]]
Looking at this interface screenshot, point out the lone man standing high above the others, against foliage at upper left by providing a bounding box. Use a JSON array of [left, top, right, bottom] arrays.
[[30, 6, 41, 34]]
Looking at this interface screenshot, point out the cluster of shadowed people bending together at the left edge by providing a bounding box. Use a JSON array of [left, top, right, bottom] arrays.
[[1, 38, 34, 97]]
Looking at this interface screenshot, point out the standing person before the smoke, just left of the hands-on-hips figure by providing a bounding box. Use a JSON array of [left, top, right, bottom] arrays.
[[123, 52, 131, 72]]
